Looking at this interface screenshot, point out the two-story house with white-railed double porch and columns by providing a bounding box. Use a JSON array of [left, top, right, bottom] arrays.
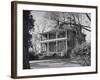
[[40, 24, 85, 56]]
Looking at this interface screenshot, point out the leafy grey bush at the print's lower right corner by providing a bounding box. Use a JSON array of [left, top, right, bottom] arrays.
[[70, 42, 91, 66]]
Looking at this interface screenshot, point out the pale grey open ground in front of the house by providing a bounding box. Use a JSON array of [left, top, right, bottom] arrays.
[[30, 59, 81, 69]]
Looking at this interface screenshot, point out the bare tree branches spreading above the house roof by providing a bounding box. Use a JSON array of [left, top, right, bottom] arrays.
[[44, 12, 91, 31]]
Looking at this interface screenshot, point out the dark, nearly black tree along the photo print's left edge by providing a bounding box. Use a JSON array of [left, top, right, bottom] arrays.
[[23, 10, 34, 69]]
